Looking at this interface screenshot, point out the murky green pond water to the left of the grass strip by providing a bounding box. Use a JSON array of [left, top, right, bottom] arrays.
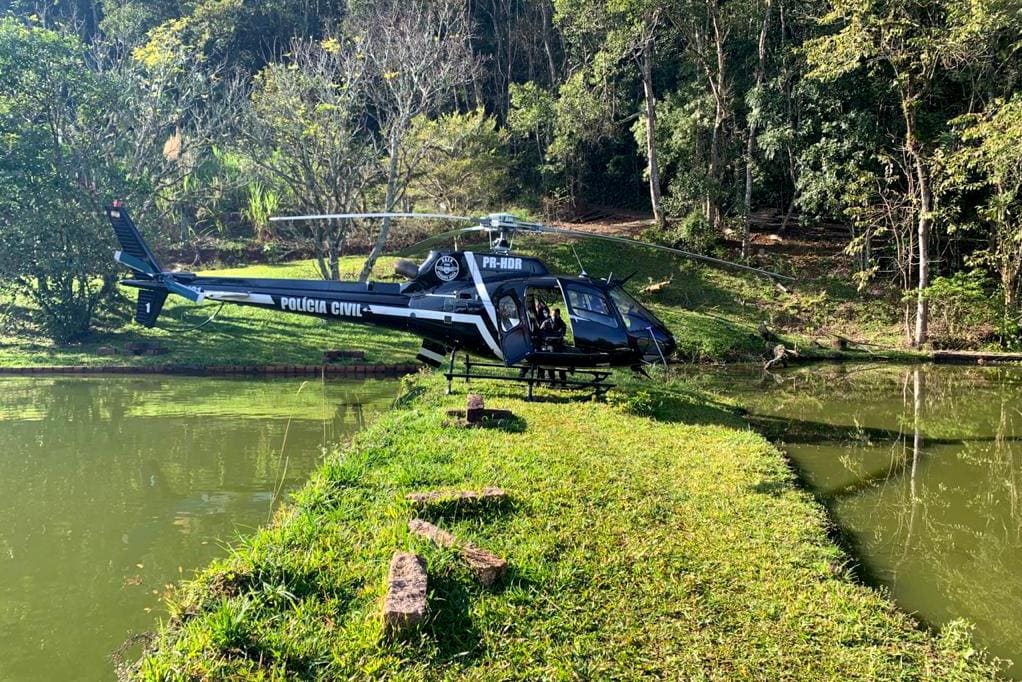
[[0, 377, 397, 680]]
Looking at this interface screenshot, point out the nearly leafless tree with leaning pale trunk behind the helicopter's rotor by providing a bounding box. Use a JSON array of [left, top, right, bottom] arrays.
[[349, 0, 476, 281]]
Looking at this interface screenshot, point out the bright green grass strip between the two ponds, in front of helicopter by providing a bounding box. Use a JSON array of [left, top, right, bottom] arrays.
[[137, 376, 994, 680]]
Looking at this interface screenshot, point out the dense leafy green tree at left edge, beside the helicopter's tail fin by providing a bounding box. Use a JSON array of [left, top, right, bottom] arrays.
[[0, 19, 119, 343]]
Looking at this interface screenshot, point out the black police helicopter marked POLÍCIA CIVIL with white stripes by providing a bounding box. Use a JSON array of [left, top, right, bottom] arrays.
[[106, 202, 791, 397]]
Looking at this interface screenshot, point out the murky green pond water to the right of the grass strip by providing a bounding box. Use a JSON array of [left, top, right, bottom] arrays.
[[702, 366, 1022, 676]]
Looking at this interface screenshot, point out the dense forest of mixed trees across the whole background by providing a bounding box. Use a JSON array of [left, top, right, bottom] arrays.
[[0, 0, 1022, 346]]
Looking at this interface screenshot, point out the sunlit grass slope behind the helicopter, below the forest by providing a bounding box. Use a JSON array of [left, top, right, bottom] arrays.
[[0, 235, 911, 366]]
